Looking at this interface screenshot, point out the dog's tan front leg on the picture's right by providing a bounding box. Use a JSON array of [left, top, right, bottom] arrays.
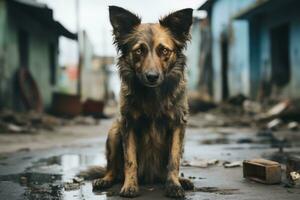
[[166, 127, 185, 198]]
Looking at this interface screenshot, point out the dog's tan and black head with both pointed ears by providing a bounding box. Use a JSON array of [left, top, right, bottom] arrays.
[[109, 6, 193, 87]]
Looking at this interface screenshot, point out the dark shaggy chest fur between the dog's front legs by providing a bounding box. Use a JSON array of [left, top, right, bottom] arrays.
[[123, 81, 187, 183]]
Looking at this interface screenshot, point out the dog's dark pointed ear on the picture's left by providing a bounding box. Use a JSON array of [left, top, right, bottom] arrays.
[[109, 6, 141, 39]]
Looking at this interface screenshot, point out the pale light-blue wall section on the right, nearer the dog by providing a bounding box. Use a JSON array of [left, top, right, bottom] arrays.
[[211, 0, 255, 102]]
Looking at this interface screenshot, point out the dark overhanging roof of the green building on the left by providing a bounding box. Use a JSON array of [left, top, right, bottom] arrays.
[[8, 0, 77, 40]]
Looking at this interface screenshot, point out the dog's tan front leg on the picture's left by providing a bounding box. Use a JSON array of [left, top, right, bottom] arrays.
[[120, 130, 139, 197]]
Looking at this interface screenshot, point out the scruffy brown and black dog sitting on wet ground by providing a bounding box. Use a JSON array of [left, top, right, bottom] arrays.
[[83, 6, 194, 198]]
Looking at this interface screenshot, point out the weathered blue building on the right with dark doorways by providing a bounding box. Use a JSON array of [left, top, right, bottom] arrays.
[[199, 0, 300, 101]]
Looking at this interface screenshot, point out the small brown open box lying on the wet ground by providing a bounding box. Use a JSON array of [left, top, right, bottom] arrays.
[[243, 159, 281, 184]]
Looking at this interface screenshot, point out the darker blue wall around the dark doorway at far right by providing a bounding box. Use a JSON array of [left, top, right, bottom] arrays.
[[250, 2, 300, 98]]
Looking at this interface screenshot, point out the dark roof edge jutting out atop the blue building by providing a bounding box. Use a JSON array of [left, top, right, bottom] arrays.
[[234, 0, 299, 19]]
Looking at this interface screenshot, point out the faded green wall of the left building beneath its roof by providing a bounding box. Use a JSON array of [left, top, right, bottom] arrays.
[[0, 1, 58, 110]]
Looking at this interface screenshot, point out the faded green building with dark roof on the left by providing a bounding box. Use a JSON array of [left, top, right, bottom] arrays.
[[0, 0, 77, 110]]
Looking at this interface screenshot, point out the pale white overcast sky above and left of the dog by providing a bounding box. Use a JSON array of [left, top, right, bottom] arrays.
[[38, 0, 205, 64]]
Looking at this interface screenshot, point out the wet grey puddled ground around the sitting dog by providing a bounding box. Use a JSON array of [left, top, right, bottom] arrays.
[[0, 116, 300, 200]]
